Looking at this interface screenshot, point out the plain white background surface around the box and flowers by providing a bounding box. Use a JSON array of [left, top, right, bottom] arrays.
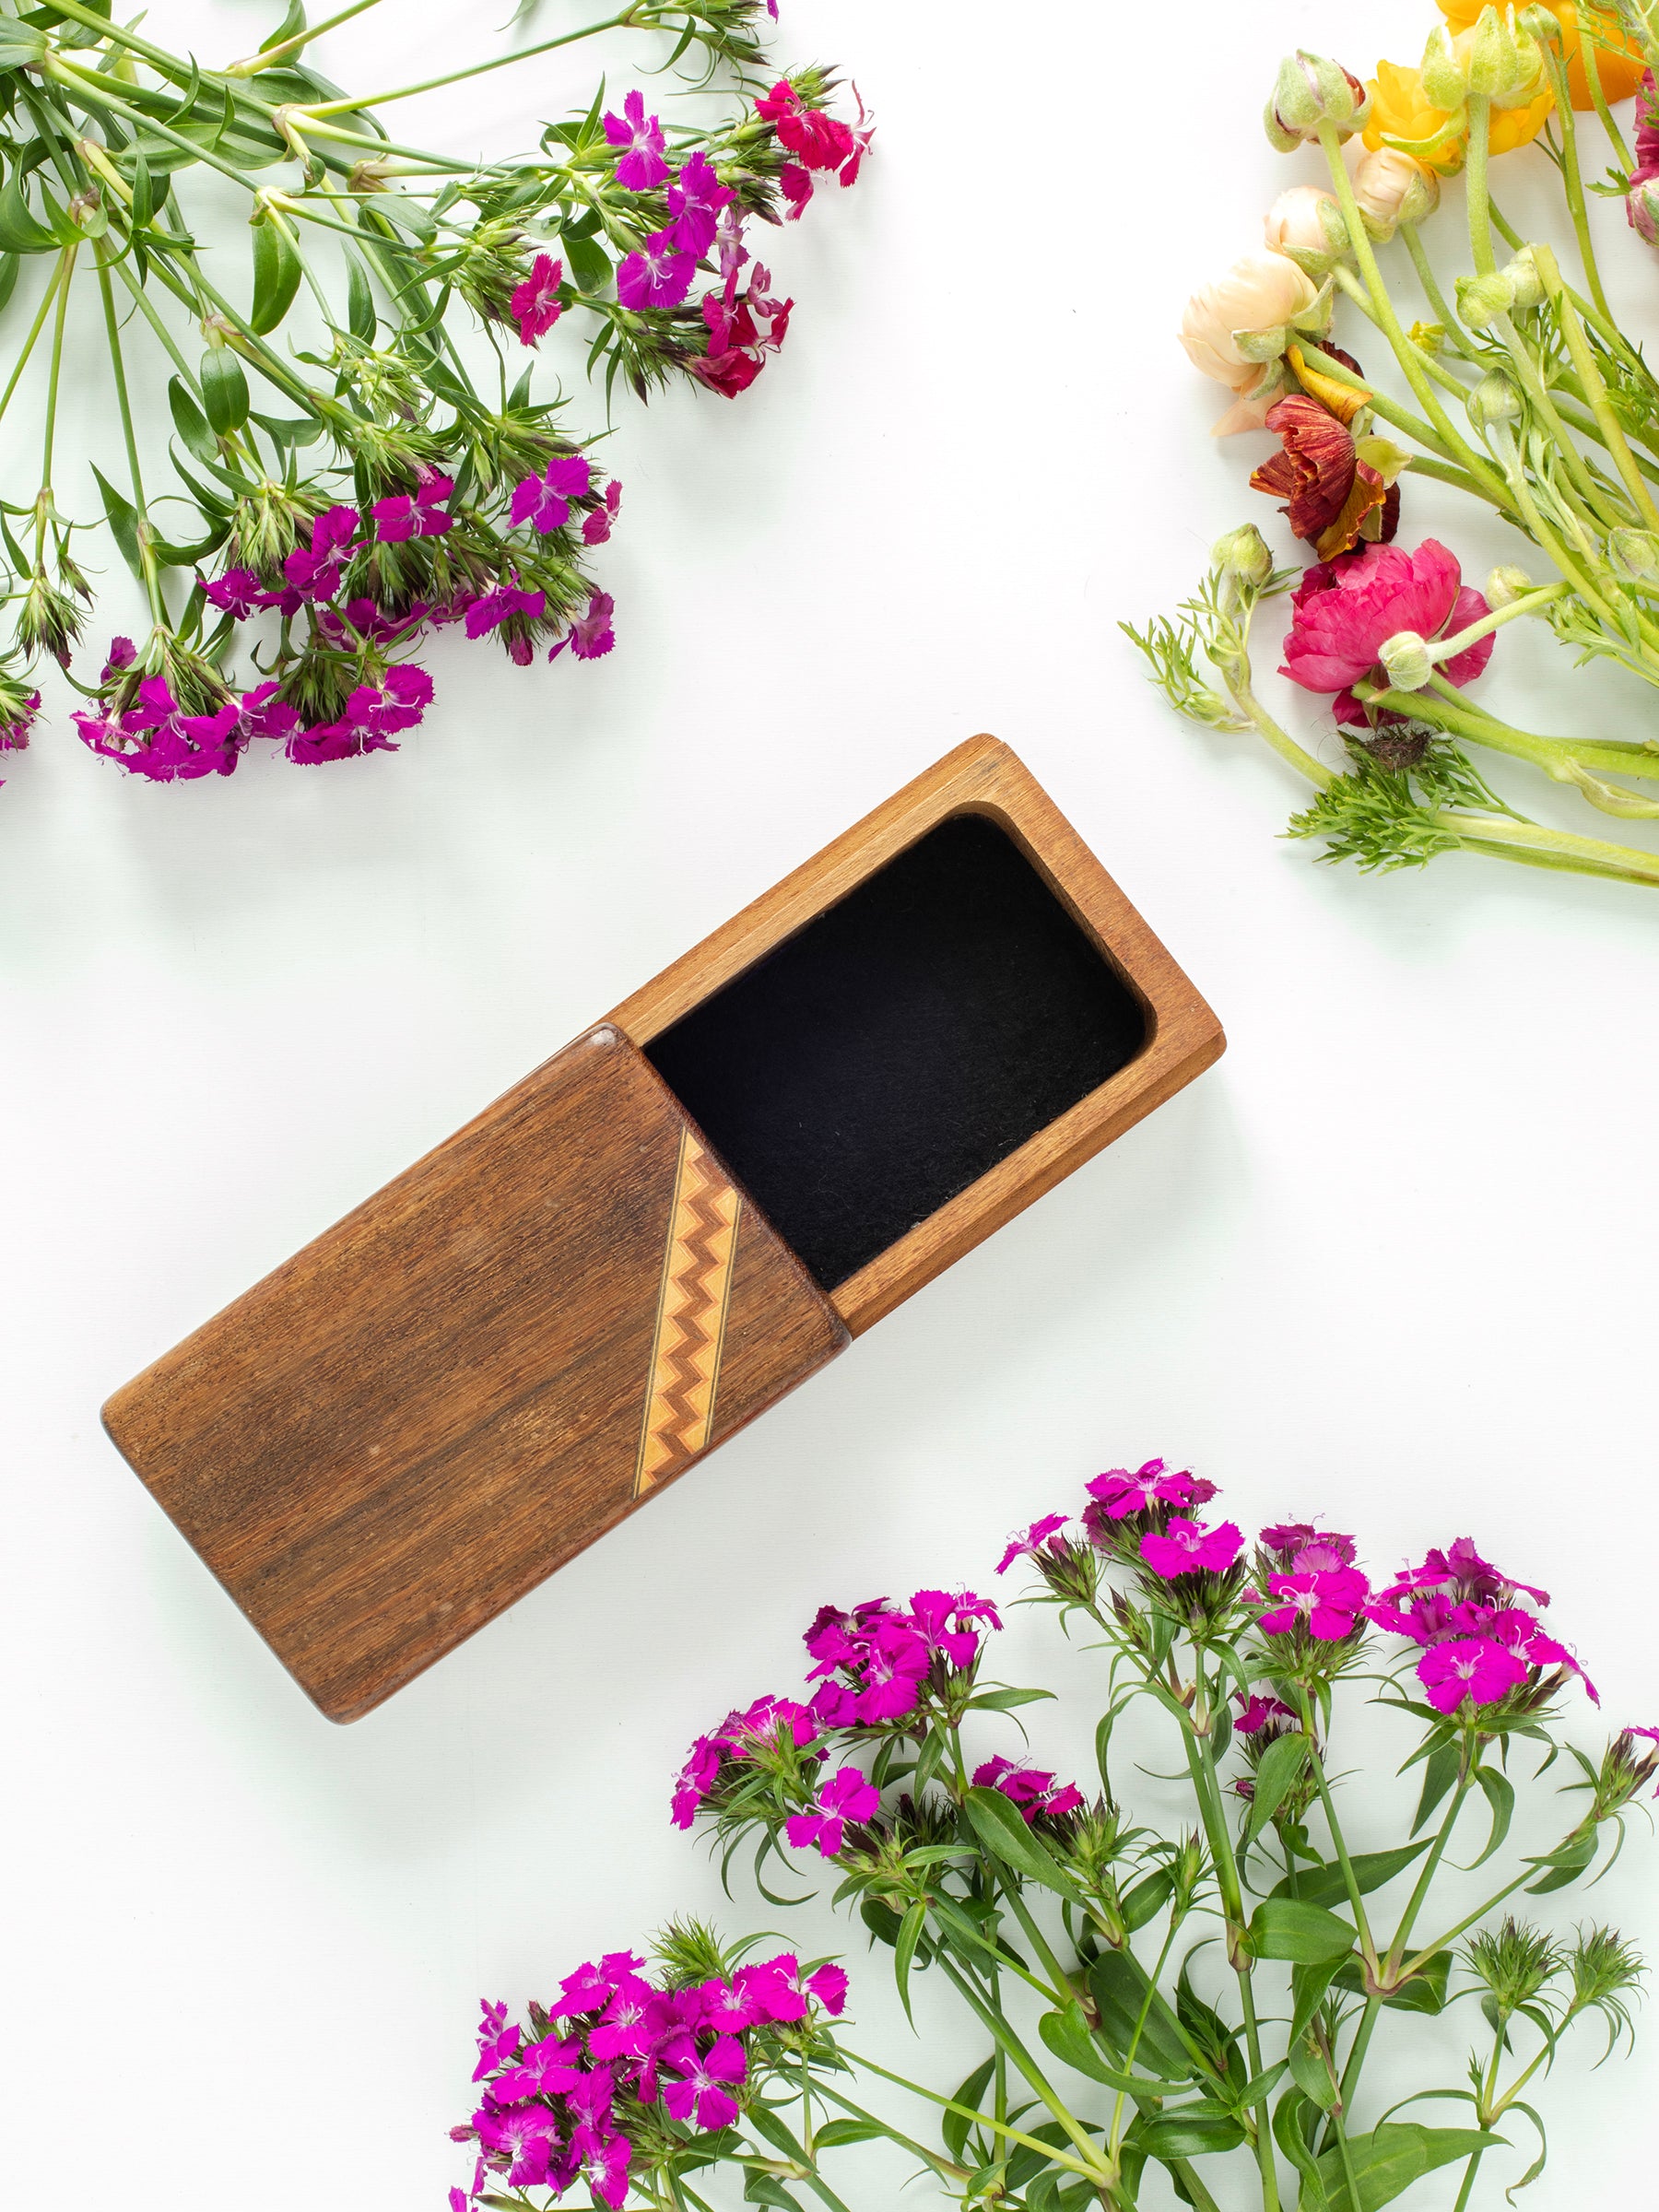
[[0, 0, 1659, 2212]]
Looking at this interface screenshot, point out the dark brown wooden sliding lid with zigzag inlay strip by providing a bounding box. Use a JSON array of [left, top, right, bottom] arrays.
[[104, 1027, 847, 1721]]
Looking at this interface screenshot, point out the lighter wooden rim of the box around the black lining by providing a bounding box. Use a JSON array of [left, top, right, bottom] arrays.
[[610, 736, 1226, 1336]]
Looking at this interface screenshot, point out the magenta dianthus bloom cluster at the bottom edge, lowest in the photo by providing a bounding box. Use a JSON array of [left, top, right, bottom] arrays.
[[449, 1951, 847, 2212]]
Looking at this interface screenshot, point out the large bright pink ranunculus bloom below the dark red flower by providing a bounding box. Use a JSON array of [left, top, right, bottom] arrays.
[[1278, 537, 1493, 692]]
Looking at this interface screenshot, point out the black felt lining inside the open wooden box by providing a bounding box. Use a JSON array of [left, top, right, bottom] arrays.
[[646, 814, 1146, 1289]]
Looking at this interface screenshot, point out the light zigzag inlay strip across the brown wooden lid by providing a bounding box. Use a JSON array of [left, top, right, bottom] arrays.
[[632, 1130, 743, 1498]]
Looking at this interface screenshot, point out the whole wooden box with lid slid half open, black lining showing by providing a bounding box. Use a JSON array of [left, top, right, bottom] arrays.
[[104, 736, 1223, 1721]]
